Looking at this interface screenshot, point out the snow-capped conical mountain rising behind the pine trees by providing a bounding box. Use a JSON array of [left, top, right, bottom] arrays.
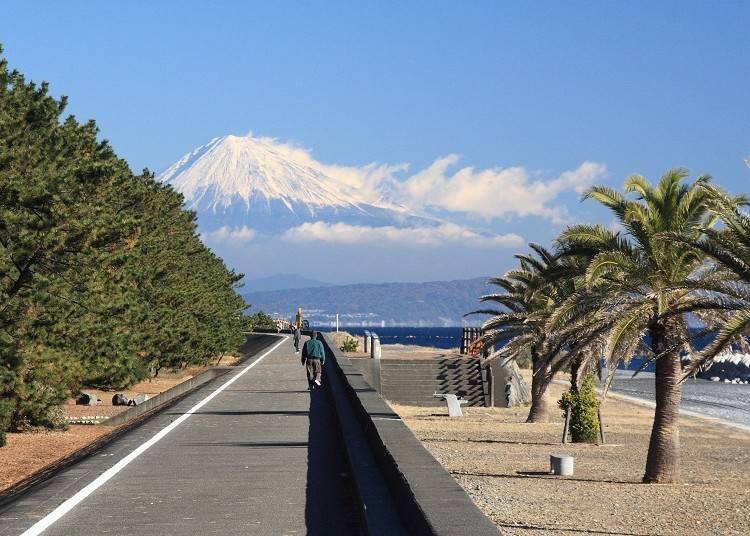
[[159, 135, 440, 233]]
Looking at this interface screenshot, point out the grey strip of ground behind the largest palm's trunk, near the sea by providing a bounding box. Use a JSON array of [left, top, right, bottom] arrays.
[[611, 370, 750, 426]]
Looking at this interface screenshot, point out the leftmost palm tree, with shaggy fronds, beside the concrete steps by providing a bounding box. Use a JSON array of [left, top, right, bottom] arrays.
[[468, 244, 562, 422]]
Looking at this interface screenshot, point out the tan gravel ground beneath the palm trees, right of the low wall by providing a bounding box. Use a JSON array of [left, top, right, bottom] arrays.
[[393, 378, 750, 536]]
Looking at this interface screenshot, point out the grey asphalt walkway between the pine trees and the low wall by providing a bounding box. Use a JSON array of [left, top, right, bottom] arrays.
[[0, 339, 359, 536]]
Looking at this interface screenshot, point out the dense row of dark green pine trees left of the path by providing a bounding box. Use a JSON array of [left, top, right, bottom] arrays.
[[0, 48, 245, 446]]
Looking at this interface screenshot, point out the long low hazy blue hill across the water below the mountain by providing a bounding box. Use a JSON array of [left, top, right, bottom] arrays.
[[245, 277, 493, 326]]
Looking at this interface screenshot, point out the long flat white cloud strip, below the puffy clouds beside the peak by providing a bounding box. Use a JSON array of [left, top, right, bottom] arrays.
[[283, 221, 524, 248]]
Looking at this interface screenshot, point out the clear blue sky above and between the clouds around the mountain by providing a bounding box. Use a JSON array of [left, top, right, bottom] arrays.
[[0, 1, 750, 280]]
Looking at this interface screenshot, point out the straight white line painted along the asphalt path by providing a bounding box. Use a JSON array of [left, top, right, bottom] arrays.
[[21, 335, 289, 536]]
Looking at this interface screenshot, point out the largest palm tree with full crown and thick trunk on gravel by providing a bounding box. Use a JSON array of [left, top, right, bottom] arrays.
[[550, 169, 715, 482]]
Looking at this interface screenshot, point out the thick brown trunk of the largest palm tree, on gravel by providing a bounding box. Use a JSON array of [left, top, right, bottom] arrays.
[[643, 325, 682, 484]]
